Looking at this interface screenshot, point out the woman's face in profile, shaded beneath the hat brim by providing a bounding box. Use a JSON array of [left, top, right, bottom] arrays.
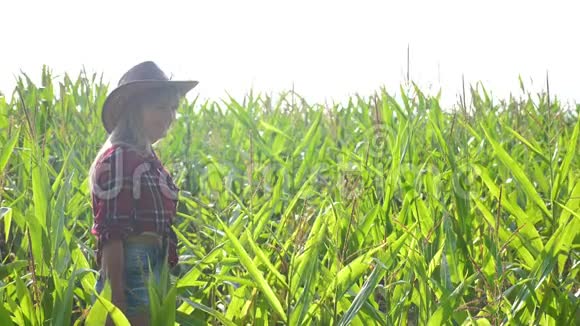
[[143, 98, 179, 144]]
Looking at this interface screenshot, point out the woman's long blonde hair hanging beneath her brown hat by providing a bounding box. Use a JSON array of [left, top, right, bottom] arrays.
[[89, 88, 179, 190]]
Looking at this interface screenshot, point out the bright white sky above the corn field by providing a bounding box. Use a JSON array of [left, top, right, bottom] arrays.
[[0, 0, 580, 107]]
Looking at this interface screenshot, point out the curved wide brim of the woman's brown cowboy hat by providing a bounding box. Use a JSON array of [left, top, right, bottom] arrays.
[[101, 80, 199, 134]]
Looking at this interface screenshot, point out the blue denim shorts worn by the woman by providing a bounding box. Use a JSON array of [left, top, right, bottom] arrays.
[[95, 242, 164, 316]]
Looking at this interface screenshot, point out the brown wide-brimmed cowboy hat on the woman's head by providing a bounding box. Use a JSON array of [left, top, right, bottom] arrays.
[[101, 61, 199, 134]]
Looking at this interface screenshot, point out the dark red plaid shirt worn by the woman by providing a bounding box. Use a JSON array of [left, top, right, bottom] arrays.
[[91, 145, 179, 266]]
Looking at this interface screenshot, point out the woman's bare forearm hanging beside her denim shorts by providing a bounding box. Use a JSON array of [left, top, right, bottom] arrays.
[[101, 239, 126, 311]]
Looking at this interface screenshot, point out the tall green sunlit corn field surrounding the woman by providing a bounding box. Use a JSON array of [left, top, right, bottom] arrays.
[[0, 68, 580, 326]]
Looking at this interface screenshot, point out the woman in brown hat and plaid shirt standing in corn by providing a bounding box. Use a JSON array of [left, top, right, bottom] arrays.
[[90, 61, 198, 325]]
